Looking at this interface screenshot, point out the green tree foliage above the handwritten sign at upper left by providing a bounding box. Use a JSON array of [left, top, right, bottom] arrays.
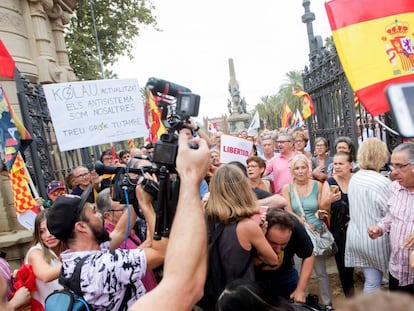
[[66, 0, 157, 80]]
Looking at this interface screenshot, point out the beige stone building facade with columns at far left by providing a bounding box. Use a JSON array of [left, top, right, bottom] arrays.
[[0, 0, 77, 267]]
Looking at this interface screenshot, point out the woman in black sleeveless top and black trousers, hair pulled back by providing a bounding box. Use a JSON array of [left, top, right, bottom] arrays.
[[322, 152, 355, 297]]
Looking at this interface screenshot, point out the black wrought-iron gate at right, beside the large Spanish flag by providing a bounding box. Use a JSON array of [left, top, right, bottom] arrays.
[[302, 46, 401, 153]]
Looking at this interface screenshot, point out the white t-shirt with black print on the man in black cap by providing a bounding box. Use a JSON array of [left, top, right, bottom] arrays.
[[61, 249, 147, 311]]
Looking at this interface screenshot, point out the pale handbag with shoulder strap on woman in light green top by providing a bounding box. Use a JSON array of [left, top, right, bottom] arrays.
[[293, 186, 338, 256]]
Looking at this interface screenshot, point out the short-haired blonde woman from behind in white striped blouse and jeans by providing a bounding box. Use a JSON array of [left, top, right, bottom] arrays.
[[345, 138, 391, 292]]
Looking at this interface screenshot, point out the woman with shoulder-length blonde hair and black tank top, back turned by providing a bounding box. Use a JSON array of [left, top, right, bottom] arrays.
[[206, 164, 278, 310]]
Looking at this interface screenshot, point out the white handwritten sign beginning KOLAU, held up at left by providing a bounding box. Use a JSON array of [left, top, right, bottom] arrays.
[[44, 79, 148, 151]]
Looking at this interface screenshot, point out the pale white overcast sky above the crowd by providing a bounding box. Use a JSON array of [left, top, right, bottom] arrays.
[[113, 0, 331, 120]]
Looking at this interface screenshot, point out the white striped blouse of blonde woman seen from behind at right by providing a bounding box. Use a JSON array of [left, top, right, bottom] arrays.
[[345, 170, 391, 273]]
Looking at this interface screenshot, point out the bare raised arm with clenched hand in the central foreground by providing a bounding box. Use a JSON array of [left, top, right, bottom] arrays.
[[130, 133, 210, 311]]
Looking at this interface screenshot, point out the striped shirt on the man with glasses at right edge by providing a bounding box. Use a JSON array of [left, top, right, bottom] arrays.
[[378, 181, 414, 286]]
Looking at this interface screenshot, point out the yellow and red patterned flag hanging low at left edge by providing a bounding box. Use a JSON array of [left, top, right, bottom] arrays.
[[9, 153, 38, 214]]
